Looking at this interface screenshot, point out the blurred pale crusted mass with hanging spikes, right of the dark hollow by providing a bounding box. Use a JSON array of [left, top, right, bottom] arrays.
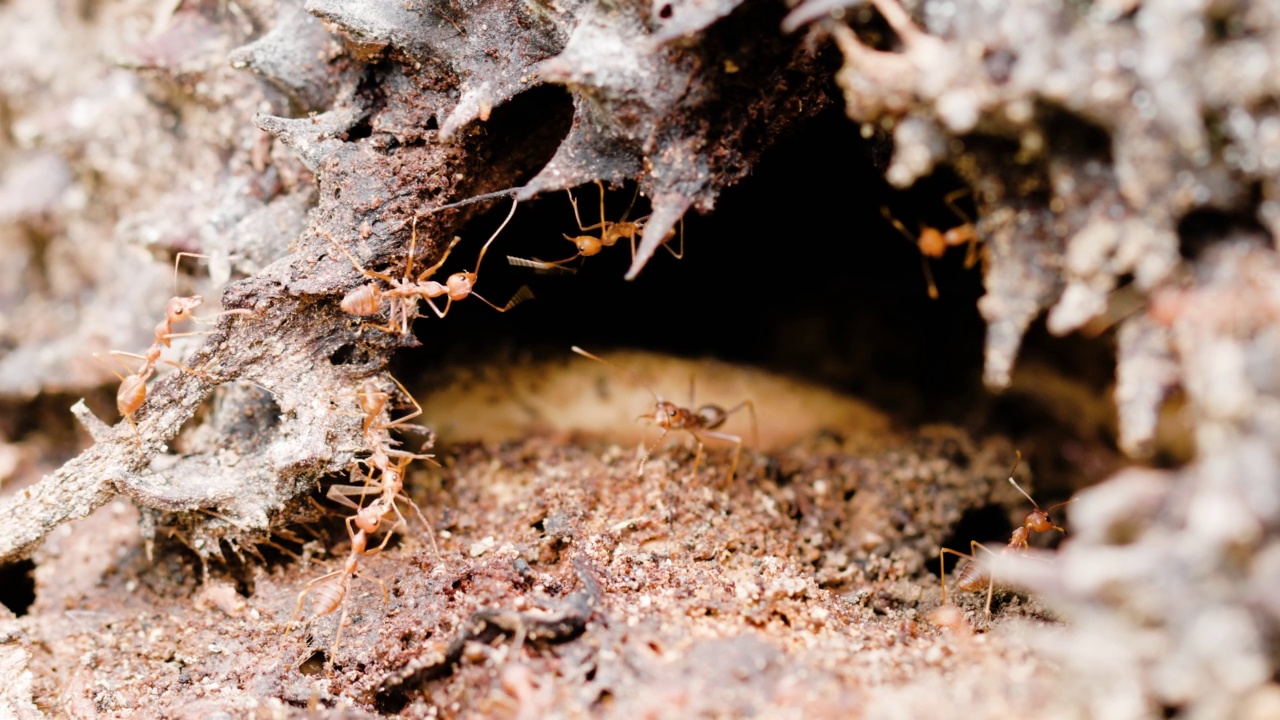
[[787, 0, 1280, 717]]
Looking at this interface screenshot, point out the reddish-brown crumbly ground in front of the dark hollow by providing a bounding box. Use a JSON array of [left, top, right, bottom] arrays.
[[0, 355, 1053, 717]]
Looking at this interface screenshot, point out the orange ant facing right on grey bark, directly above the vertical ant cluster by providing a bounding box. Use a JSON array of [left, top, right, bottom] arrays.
[[330, 196, 534, 334]]
